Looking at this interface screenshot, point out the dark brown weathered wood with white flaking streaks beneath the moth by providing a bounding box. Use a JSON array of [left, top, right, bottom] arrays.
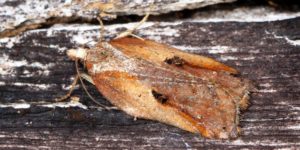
[[0, 4, 300, 149]]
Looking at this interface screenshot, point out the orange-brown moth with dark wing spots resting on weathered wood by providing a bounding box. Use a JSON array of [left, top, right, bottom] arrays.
[[68, 37, 252, 139]]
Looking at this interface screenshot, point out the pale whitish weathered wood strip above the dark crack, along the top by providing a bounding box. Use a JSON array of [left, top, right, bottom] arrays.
[[0, 0, 235, 38]]
